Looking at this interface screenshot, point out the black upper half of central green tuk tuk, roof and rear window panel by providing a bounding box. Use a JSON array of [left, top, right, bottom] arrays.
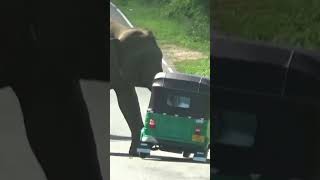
[[149, 72, 210, 119]]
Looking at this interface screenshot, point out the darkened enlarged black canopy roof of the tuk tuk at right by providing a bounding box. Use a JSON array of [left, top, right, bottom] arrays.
[[211, 36, 320, 97]]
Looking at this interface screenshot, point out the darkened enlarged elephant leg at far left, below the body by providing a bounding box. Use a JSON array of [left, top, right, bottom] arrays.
[[12, 79, 102, 180]]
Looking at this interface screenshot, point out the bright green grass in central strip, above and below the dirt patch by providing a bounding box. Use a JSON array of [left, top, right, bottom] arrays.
[[112, 0, 210, 76]]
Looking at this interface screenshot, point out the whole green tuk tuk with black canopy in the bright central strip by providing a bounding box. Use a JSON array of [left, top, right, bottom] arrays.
[[137, 72, 210, 162]]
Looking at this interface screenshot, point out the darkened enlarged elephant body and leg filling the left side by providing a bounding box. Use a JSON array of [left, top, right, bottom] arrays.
[[0, 0, 104, 180]]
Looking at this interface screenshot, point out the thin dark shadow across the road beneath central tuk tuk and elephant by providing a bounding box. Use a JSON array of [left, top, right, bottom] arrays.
[[110, 152, 210, 164]]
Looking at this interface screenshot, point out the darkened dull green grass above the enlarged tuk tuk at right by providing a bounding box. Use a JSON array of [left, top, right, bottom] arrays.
[[211, 0, 320, 49]]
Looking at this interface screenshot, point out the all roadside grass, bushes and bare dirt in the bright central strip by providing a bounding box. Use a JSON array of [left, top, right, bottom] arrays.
[[112, 0, 210, 77]]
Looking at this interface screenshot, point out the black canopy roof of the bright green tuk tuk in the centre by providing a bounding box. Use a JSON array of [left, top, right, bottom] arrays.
[[152, 72, 210, 96]]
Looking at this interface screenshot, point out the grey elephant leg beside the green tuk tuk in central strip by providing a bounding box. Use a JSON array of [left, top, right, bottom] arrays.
[[114, 83, 143, 155]]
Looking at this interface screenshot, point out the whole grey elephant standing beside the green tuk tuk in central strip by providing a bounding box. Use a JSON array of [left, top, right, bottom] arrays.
[[110, 19, 162, 156]]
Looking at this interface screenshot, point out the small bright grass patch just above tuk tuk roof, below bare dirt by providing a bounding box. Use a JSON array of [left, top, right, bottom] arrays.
[[175, 59, 210, 77]]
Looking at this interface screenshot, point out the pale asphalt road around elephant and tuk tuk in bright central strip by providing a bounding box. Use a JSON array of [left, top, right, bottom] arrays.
[[110, 2, 210, 180]]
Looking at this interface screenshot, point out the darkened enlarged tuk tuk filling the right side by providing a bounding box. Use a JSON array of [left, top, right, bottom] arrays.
[[212, 37, 320, 179]]
